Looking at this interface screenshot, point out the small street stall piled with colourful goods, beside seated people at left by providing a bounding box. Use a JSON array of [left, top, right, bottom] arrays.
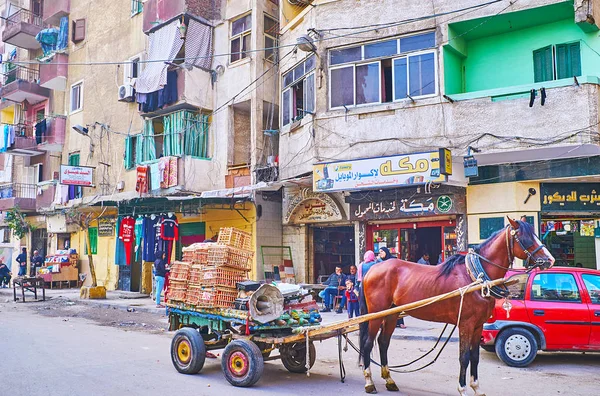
[[38, 250, 79, 289]]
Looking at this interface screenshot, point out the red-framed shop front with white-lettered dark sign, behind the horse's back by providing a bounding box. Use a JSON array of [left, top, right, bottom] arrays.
[[346, 185, 467, 265]]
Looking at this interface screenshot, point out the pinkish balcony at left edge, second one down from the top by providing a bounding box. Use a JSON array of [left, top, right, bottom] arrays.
[[0, 66, 50, 104]]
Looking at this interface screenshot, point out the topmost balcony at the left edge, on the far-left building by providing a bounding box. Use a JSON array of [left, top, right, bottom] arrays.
[[2, 10, 43, 50]]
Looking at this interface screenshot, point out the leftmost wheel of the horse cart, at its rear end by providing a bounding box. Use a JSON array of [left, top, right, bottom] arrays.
[[171, 327, 206, 374]]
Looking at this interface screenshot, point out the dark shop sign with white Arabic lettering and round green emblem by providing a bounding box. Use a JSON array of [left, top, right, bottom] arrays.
[[350, 194, 465, 220]]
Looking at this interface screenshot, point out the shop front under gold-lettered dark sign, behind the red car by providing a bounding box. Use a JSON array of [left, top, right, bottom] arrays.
[[540, 183, 600, 269]]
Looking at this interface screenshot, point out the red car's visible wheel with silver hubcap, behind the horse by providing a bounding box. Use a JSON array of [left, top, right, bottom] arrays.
[[496, 327, 538, 367]]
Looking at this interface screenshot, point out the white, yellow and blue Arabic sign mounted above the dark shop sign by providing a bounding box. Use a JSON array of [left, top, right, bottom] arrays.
[[313, 149, 452, 192]]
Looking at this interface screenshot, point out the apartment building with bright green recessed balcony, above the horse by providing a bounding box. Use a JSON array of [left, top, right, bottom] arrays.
[[279, 0, 600, 282]]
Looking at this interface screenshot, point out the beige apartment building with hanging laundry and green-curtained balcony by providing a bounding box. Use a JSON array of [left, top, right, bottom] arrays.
[[0, 0, 282, 293]]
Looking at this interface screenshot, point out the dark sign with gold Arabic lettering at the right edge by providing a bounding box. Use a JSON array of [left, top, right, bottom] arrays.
[[540, 183, 600, 211]]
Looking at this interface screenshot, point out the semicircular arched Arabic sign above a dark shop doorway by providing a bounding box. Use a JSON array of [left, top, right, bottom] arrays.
[[283, 188, 344, 224]]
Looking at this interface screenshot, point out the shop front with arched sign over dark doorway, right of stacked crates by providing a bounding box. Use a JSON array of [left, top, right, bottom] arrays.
[[283, 188, 356, 283]]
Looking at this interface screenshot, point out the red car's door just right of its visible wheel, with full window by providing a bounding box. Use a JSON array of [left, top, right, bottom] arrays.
[[525, 271, 591, 349]]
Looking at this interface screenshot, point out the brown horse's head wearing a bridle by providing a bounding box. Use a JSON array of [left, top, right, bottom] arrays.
[[506, 217, 555, 269]]
